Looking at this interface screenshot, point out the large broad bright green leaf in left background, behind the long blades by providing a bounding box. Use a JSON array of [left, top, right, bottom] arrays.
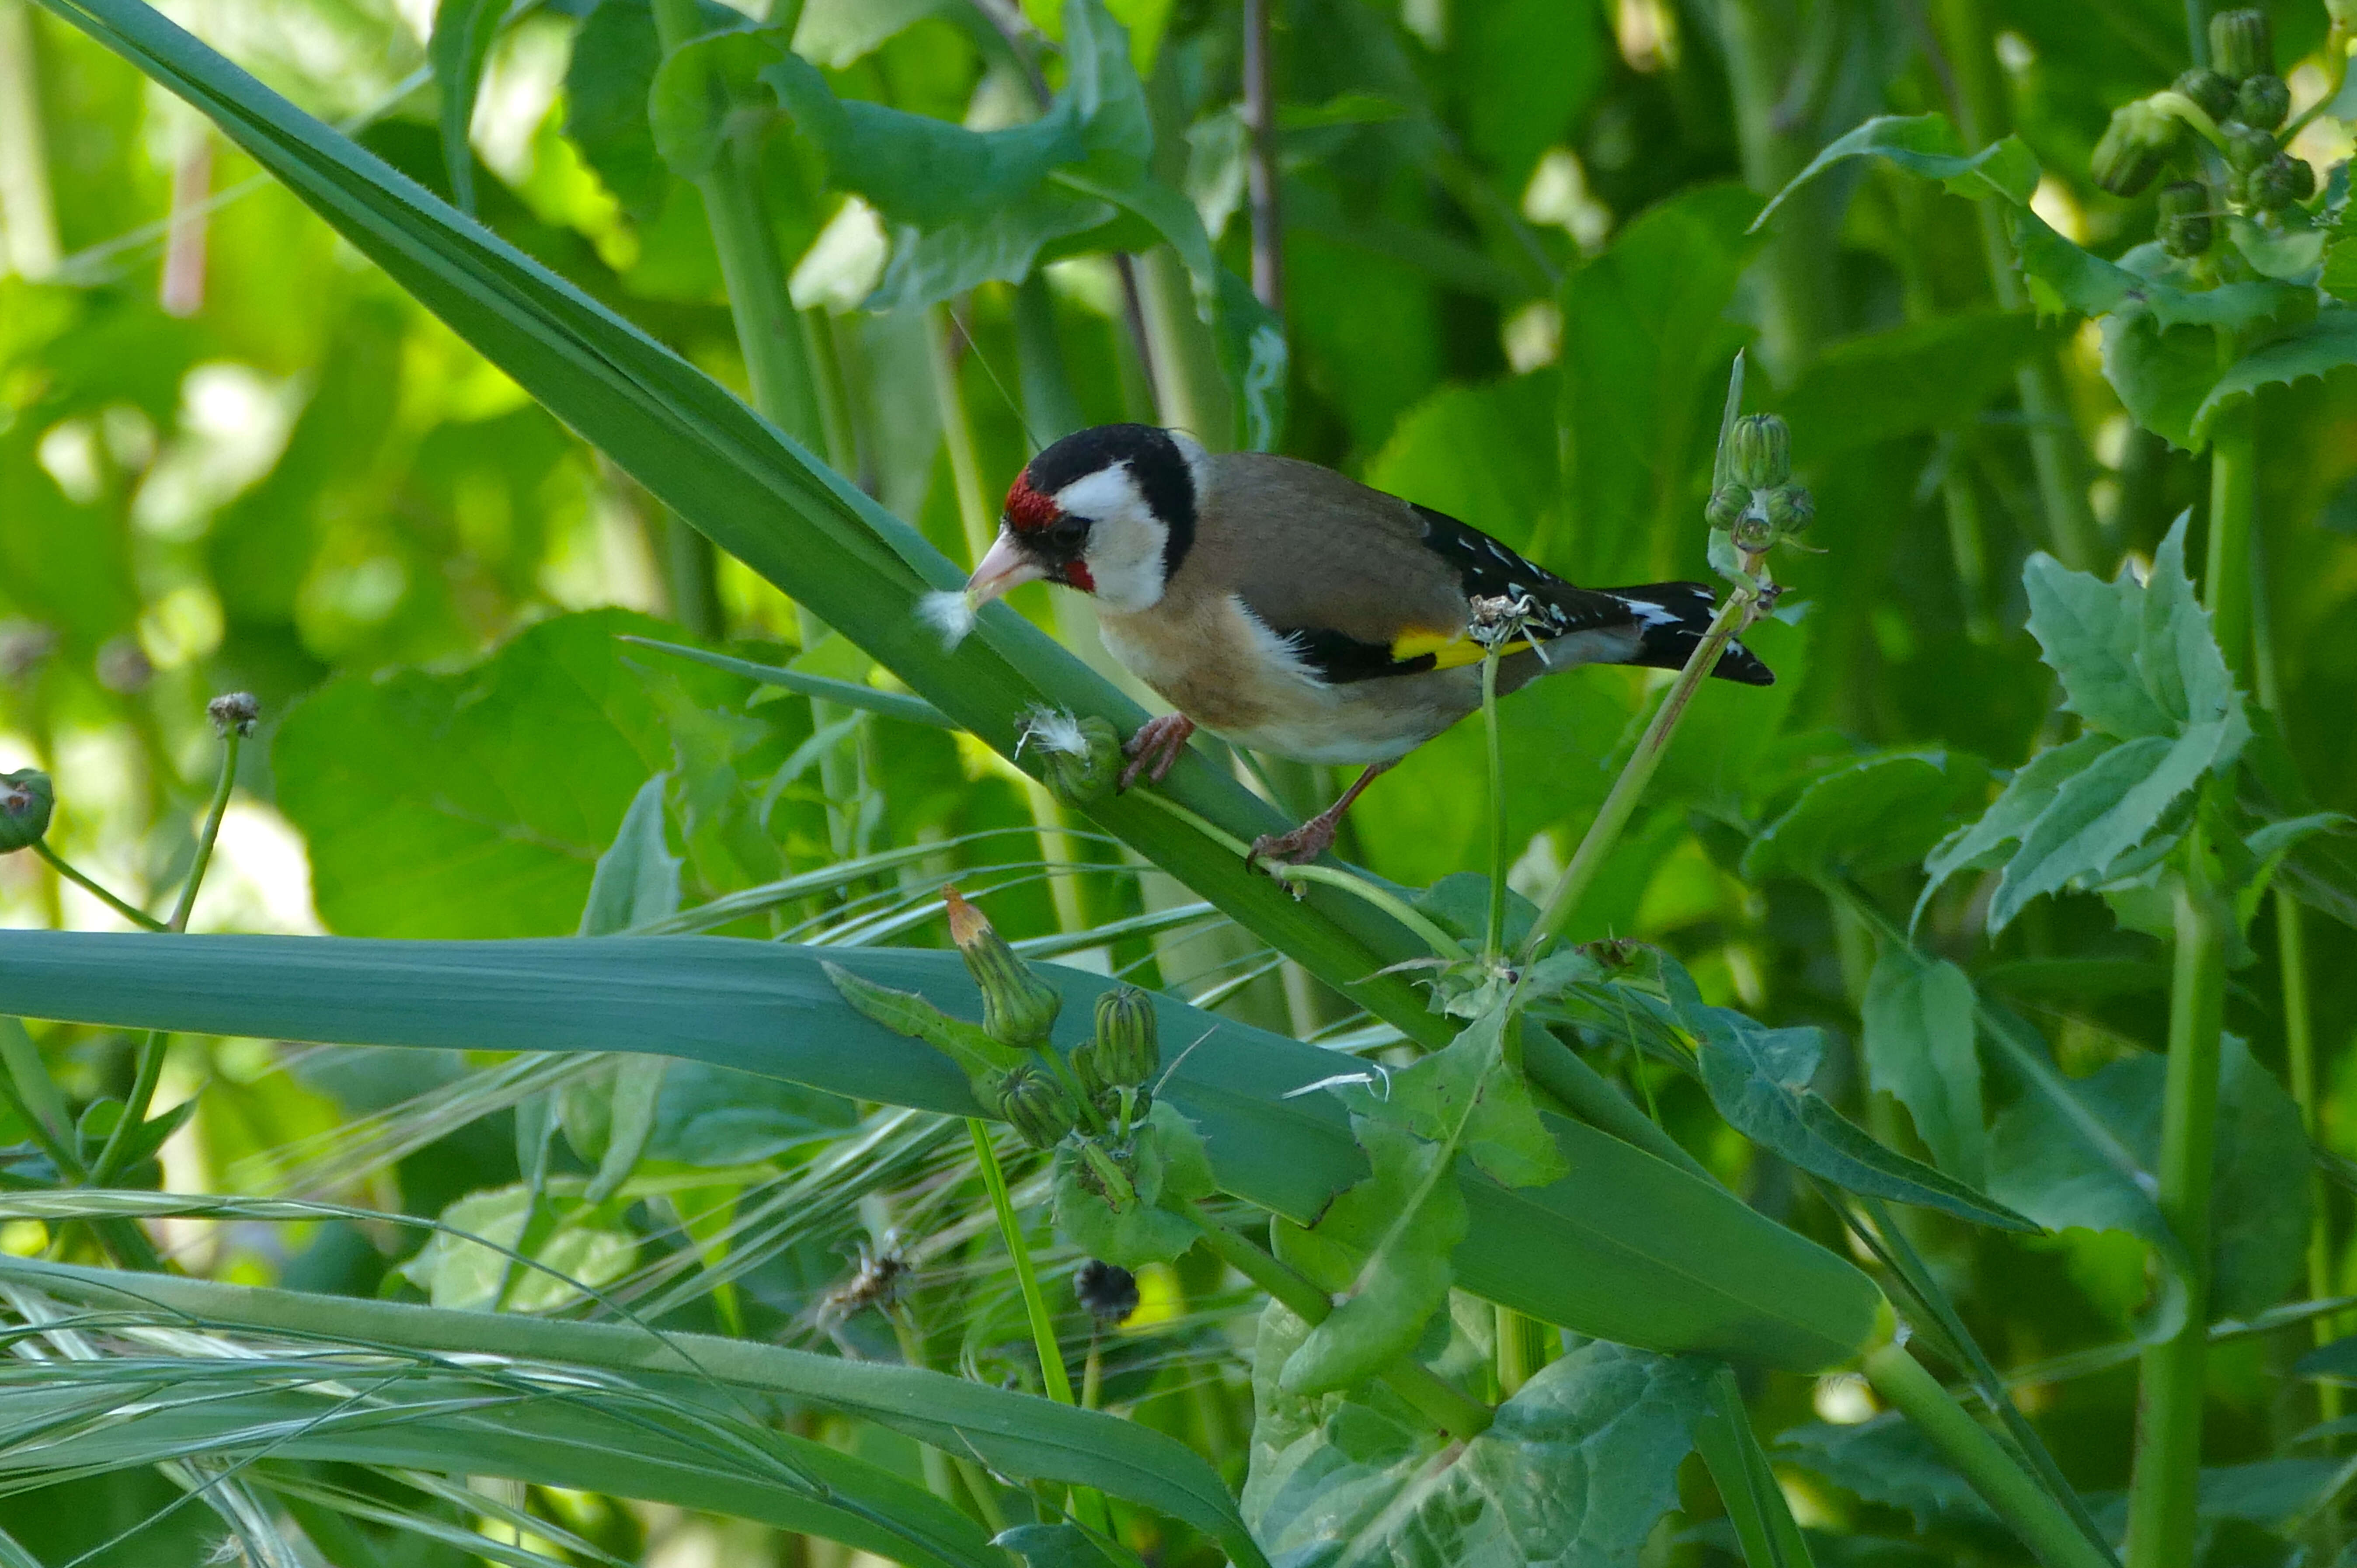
[[271, 611, 672, 936]]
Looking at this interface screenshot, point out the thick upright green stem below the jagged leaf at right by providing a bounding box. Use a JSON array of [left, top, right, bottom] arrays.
[[2128, 848, 2225, 1568]]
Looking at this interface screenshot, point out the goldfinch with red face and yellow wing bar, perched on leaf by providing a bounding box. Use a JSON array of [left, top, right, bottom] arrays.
[[964, 424, 1775, 866]]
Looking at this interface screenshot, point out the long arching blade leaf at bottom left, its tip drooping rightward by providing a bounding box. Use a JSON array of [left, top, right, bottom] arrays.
[[0, 1255, 1266, 1566]]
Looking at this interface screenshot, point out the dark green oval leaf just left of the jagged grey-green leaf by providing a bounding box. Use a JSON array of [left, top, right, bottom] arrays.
[[1742, 752, 1987, 882]]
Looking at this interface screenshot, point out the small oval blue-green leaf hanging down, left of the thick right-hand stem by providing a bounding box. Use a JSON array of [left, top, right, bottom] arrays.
[[1859, 943, 1989, 1189]]
